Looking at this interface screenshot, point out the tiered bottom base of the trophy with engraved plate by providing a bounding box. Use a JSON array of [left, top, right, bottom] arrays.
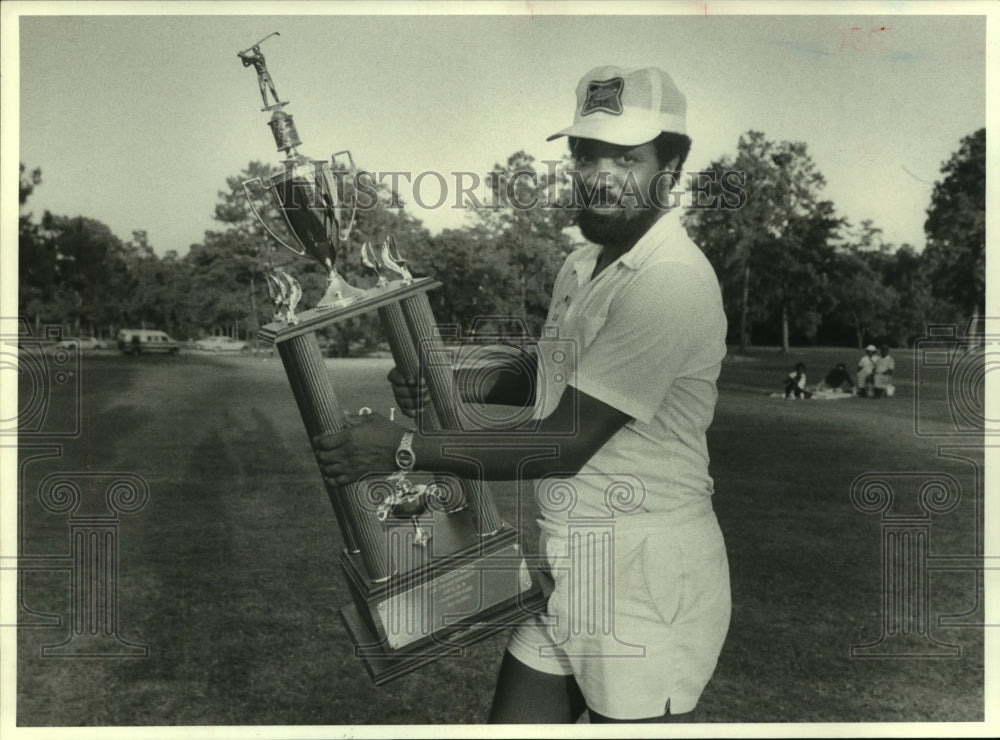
[[340, 515, 545, 685]]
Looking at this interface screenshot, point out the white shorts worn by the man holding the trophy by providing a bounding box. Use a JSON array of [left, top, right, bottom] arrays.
[[507, 502, 732, 720]]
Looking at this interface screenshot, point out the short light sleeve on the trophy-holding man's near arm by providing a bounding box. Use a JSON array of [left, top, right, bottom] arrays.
[[572, 262, 726, 424]]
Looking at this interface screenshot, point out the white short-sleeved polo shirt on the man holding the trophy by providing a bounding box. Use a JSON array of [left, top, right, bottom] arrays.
[[536, 209, 726, 523]]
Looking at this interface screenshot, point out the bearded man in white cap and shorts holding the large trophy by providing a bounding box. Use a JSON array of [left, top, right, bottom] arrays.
[[315, 67, 731, 723]]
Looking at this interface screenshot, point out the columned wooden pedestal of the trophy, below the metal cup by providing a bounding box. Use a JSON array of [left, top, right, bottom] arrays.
[[259, 278, 544, 684]]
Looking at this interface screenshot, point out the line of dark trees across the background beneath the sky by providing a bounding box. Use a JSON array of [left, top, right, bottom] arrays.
[[18, 129, 986, 356]]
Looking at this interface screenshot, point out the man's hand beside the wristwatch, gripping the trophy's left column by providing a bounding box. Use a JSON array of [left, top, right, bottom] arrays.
[[313, 414, 406, 486]]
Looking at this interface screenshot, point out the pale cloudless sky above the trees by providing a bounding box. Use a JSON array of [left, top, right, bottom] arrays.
[[3, 2, 987, 254]]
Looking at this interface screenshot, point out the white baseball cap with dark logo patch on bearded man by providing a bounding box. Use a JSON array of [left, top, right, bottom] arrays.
[[546, 66, 687, 146]]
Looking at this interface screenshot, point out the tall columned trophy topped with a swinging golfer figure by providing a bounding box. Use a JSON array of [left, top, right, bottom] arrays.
[[239, 34, 544, 684]]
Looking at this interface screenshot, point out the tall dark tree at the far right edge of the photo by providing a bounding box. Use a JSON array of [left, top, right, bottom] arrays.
[[923, 128, 986, 315]]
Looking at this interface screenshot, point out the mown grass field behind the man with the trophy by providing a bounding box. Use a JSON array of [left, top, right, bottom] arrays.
[[17, 349, 984, 724]]
